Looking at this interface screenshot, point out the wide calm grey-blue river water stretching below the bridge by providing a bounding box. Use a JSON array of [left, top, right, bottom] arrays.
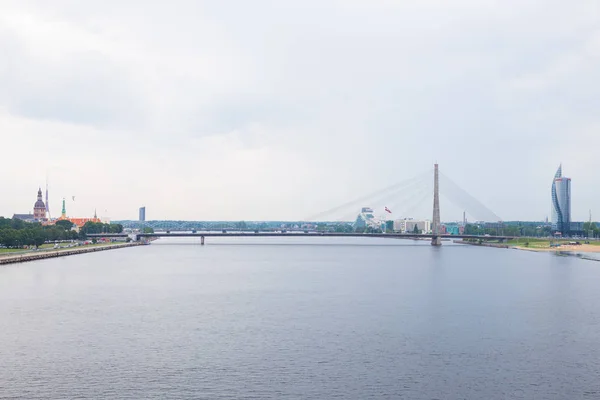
[[0, 238, 600, 400]]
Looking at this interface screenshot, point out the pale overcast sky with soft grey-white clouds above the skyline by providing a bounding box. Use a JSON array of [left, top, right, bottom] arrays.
[[0, 0, 600, 220]]
